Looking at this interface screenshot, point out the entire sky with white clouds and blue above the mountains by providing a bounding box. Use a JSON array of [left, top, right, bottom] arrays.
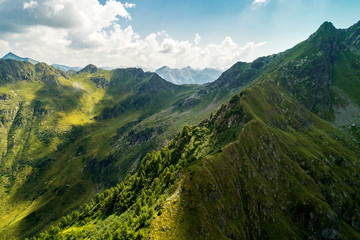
[[0, 0, 360, 70]]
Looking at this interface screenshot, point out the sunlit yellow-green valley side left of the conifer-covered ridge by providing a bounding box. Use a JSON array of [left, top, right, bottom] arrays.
[[0, 58, 262, 238]]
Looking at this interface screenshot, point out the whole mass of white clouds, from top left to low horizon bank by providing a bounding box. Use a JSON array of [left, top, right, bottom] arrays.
[[0, 0, 266, 69]]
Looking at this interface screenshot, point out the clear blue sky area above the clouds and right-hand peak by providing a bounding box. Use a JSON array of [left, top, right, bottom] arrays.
[[111, 0, 360, 52]]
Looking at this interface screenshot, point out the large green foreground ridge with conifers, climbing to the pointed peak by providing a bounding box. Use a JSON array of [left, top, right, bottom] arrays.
[[28, 23, 360, 239]]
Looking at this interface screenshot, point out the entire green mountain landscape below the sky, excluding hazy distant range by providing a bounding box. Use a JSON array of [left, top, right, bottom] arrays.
[[0, 22, 360, 240]]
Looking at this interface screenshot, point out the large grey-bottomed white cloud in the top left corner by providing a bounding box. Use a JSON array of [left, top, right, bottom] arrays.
[[0, 0, 131, 33]]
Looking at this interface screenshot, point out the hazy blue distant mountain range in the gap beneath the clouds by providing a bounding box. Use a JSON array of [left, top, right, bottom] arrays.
[[155, 66, 221, 84]]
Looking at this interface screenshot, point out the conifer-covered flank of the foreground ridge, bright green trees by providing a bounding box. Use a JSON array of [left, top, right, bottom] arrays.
[[26, 91, 250, 239]]
